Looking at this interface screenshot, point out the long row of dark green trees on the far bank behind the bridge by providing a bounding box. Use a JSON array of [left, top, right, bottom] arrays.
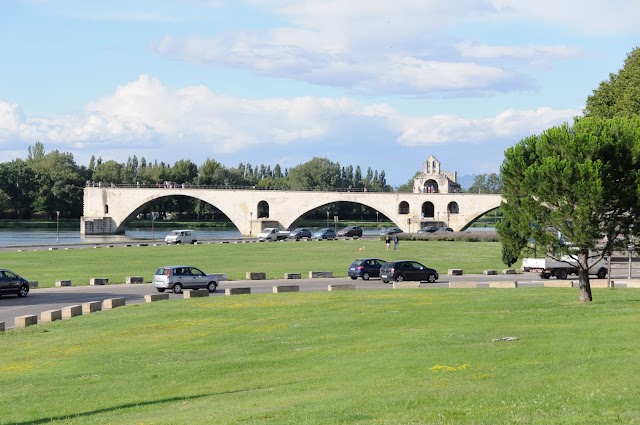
[[0, 147, 392, 219]]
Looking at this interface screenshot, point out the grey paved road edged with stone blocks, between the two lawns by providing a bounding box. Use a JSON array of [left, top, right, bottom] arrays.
[[0, 265, 627, 329]]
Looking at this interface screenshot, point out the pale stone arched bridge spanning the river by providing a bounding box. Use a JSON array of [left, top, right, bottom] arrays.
[[81, 187, 502, 236]]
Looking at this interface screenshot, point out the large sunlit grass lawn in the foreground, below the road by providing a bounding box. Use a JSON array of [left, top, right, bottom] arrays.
[[0, 286, 640, 425]]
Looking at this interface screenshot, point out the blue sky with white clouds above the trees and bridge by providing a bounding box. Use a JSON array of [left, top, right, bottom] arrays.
[[0, 0, 640, 186]]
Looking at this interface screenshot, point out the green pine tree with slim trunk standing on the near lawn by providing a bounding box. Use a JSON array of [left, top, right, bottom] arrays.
[[498, 118, 640, 302]]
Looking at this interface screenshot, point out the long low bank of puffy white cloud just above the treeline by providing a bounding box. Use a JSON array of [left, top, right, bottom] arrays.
[[0, 75, 580, 155]]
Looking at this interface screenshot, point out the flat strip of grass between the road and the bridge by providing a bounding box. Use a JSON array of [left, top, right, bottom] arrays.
[[0, 240, 505, 287]]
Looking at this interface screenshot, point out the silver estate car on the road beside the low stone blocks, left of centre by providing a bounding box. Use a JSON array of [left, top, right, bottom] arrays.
[[152, 266, 227, 294]]
